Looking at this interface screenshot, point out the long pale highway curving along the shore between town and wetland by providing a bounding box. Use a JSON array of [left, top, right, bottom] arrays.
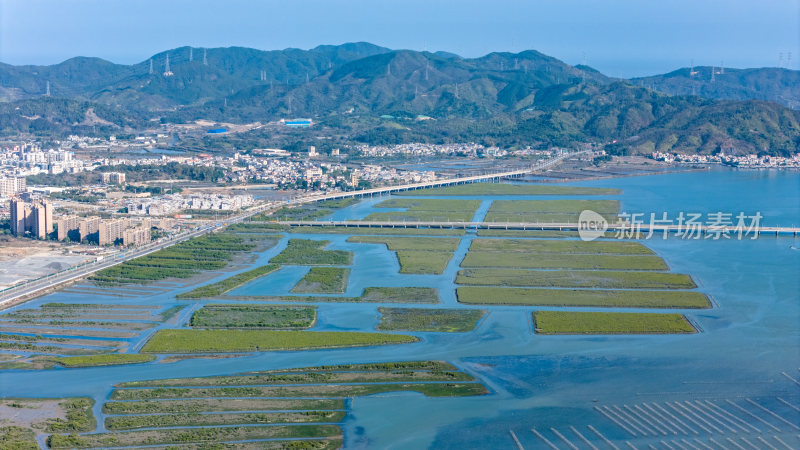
[[0, 151, 587, 309]]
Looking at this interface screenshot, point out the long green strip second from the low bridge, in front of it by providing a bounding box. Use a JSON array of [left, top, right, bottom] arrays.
[[461, 251, 669, 270]]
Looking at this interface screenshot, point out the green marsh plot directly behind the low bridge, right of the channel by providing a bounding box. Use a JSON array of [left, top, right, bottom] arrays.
[[485, 200, 619, 223]]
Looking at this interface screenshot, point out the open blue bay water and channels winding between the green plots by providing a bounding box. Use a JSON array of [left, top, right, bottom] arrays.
[[0, 170, 800, 448]]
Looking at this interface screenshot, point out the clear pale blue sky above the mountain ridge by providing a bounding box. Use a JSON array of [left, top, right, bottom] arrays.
[[0, 0, 800, 76]]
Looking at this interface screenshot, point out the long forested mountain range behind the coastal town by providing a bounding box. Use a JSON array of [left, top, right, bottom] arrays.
[[0, 43, 800, 154]]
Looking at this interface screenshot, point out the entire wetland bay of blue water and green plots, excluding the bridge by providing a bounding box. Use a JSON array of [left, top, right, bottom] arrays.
[[0, 170, 800, 449]]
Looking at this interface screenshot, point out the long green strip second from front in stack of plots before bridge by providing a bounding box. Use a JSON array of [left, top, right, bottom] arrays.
[[456, 269, 697, 289]]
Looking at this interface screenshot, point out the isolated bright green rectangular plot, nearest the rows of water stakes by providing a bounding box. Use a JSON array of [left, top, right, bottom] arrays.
[[533, 311, 697, 334]]
